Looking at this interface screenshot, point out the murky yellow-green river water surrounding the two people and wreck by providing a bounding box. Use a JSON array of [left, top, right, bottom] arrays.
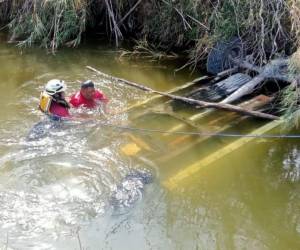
[[0, 34, 300, 249]]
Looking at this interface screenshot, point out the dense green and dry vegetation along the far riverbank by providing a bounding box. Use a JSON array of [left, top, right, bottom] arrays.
[[0, 0, 300, 123]]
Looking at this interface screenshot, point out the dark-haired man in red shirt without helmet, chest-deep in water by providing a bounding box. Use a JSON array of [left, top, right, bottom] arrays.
[[70, 80, 108, 112]]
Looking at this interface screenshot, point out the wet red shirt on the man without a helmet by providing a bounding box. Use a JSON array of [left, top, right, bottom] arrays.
[[70, 90, 108, 109]]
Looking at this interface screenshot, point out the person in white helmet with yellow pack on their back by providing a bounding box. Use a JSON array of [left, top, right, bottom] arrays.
[[39, 79, 70, 118]]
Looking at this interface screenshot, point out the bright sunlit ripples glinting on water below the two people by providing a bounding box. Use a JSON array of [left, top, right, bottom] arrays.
[[0, 112, 155, 249]]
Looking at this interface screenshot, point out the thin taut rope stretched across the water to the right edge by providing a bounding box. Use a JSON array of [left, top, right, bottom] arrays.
[[97, 122, 300, 139]]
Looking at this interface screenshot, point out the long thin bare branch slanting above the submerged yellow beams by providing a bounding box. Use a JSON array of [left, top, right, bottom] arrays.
[[86, 66, 279, 120]]
